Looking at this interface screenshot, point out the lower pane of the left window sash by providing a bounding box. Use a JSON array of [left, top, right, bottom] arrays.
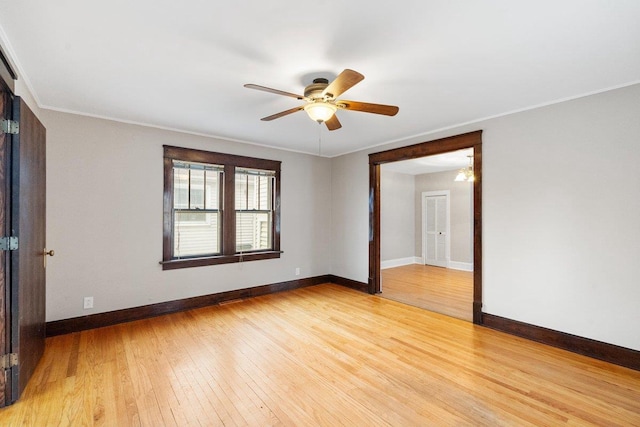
[[173, 212, 220, 258]]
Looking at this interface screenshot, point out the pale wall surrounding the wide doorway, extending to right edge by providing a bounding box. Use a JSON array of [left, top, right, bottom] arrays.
[[332, 85, 640, 350]]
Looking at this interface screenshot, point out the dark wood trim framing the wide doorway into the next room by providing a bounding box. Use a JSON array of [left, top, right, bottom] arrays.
[[368, 130, 482, 325]]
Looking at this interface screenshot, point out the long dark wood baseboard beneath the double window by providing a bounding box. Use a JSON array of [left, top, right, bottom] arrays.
[[46, 275, 331, 337]]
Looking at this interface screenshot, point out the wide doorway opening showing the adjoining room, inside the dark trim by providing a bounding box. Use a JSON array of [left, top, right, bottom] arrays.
[[380, 148, 473, 322]]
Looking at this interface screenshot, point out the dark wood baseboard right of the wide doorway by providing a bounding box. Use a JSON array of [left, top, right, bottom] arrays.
[[482, 313, 640, 371]]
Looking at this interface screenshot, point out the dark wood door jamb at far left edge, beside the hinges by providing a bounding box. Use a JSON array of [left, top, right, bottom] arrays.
[[0, 67, 12, 407]]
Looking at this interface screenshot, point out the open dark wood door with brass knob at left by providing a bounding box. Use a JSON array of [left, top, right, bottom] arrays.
[[10, 97, 46, 402]]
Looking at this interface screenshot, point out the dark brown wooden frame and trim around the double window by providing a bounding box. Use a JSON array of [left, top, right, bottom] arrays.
[[160, 145, 282, 270]]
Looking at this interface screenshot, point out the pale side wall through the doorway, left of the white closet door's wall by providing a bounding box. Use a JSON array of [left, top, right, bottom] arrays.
[[380, 168, 416, 262]]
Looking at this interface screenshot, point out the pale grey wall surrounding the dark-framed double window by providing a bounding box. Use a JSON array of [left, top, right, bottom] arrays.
[[40, 110, 331, 321]]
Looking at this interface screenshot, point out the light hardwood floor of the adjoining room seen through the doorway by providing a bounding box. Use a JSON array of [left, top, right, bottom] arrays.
[[381, 264, 473, 322]]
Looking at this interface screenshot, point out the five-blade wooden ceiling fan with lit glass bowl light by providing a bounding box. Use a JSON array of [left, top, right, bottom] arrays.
[[244, 69, 399, 130]]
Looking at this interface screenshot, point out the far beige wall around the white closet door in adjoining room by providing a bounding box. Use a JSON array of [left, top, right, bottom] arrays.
[[412, 171, 473, 264]]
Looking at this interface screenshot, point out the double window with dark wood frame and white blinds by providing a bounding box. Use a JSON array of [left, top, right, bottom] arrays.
[[162, 146, 280, 270]]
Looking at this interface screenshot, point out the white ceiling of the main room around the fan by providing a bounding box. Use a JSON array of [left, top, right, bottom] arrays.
[[0, 0, 640, 156]]
